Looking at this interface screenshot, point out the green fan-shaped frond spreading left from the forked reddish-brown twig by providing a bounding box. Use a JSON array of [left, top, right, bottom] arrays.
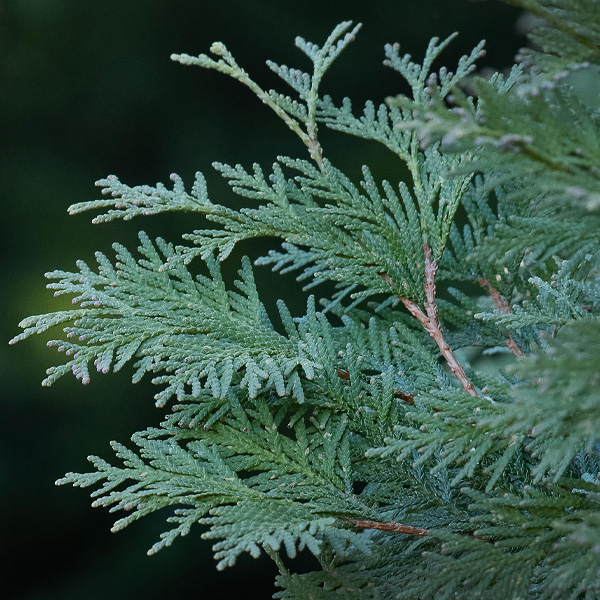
[[173, 149, 469, 299]]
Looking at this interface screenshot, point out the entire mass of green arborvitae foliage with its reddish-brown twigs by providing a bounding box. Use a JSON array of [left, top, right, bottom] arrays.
[[15, 0, 600, 600]]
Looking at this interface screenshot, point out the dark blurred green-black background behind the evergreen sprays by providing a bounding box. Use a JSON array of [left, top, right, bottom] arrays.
[[0, 0, 524, 600]]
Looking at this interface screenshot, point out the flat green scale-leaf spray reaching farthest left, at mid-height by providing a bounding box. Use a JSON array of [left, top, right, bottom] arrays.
[[14, 233, 319, 405]]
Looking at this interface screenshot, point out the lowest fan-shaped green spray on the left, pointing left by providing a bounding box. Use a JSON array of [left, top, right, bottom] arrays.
[[58, 396, 376, 569]]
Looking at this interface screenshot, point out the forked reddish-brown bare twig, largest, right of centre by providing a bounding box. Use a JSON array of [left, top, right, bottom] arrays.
[[380, 244, 478, 396]]
